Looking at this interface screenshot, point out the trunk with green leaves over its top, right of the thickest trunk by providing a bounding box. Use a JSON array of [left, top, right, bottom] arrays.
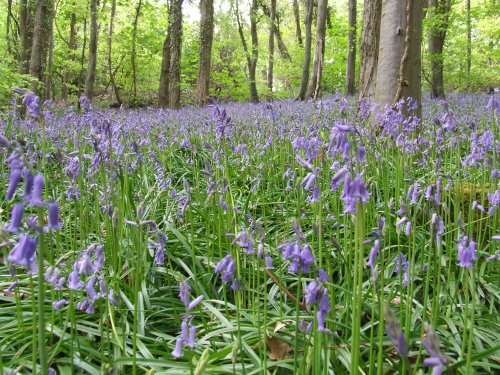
[[428, 0, 452, 99]]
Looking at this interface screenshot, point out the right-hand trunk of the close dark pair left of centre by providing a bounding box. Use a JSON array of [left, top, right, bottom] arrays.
[[167, 0, 182, 109]]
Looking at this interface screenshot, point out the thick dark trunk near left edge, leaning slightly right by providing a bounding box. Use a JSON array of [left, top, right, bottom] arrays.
[[29, 0, 52, 100]]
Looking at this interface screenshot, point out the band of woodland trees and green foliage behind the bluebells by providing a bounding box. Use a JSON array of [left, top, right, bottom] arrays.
[[0, 0, 500, 108]]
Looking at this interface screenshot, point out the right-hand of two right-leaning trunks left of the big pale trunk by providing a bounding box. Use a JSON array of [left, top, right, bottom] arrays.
[[306, 0, 328, 99]]
